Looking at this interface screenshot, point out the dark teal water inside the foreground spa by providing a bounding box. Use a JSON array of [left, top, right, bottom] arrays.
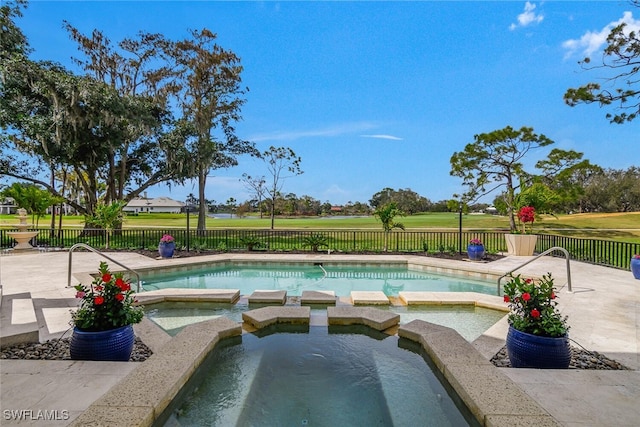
[[164, 327, 478, 427]]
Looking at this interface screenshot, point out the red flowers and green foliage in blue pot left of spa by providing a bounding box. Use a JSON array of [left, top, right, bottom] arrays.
[[70, 262, 144, 332]]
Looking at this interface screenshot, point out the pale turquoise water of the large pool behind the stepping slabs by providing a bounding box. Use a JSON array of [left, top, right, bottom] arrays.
[[143, 264, 497, 297]]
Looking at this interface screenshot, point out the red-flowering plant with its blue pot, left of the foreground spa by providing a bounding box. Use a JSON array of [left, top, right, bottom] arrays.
[[70, 262, 144, 361]]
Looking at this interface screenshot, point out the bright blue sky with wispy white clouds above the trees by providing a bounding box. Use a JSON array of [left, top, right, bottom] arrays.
[[11, 0, 640, 204]]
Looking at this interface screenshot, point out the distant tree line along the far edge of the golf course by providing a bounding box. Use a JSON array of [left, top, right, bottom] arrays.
[[187, 166, 640, 217]]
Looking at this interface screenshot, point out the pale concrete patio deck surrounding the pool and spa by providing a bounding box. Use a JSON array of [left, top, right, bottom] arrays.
[[0, 252, 640, 426]]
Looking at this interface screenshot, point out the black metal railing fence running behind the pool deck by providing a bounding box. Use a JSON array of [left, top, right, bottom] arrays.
[[0, 228, 640, 270]]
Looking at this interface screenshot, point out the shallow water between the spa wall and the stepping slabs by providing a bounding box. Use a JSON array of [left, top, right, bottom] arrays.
[[145, 302, 505, 342]]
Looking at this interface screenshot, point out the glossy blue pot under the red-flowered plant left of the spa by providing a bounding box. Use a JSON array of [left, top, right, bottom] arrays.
[[70, 325, 135, 362]]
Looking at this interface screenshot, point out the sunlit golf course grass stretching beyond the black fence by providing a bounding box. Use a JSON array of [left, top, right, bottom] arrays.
[[0, 212, 640, 243]]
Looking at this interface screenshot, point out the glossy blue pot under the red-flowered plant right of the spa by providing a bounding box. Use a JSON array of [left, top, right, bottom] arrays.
[[507, 326, 571, 369]]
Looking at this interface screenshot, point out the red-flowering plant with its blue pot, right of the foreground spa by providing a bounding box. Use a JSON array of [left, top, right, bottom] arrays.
[[504, 273, 571, 369]]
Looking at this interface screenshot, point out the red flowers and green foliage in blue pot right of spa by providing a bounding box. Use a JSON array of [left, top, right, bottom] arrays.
[[504, 273, 569, 338]]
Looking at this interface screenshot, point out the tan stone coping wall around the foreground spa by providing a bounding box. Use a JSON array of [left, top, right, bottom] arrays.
[[71, 307, 560, 427]]
